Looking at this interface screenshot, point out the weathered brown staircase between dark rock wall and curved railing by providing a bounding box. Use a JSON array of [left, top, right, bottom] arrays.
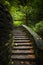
[[11, 28, 37, 65]]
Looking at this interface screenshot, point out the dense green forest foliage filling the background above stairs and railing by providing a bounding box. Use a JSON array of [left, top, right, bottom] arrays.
[[0, 0, 43, 37]]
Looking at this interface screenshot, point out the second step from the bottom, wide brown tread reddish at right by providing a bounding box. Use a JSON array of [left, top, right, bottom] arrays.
[[11, 54, 36, 60]]
